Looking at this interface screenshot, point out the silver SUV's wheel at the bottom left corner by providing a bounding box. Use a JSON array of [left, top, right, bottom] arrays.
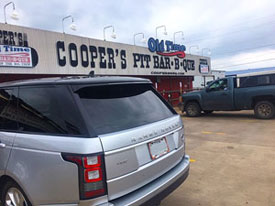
[[1, 181, 31, 206]]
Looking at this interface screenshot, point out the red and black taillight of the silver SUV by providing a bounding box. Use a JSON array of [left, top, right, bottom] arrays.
[[62, 154, 107, 200]]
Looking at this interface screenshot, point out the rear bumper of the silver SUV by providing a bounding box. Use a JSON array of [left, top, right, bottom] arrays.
[[105, 155, 190, 206]]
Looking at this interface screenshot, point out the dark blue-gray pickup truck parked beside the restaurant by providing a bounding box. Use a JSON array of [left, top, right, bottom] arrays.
[[182, 74, 275, 119]]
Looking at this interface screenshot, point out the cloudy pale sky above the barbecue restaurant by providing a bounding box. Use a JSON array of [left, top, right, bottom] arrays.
[[3, 0, 275, 71]]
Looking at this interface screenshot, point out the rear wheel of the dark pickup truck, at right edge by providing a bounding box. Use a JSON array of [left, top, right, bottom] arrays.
[[254, 101, 275, 119]]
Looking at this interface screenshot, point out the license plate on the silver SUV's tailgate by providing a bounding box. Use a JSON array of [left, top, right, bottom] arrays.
[[148, 137, 169, 160]]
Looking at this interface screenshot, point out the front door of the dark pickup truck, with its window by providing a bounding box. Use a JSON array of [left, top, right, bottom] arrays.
[[202, 79, 234, 110]]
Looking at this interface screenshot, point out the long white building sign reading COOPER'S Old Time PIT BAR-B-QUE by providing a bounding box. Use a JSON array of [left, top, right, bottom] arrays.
[[0, 24, 210, 76]]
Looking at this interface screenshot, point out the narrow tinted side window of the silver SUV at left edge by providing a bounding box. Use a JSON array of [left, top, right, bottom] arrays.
[[0, 89, 17, 131]]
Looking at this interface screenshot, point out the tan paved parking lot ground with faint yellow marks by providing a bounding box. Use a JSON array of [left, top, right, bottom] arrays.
[[161, 111, 275, 206]]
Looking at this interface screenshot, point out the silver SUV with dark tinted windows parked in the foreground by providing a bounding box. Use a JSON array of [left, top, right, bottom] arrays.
[[0, 77, 189, 206]]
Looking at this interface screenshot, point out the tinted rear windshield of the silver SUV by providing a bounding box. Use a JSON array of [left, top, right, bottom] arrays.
[[76, 85, 173, 135]]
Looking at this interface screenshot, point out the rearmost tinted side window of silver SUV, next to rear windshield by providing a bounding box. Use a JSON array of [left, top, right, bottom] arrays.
[[18, 87, 87, 135]]
